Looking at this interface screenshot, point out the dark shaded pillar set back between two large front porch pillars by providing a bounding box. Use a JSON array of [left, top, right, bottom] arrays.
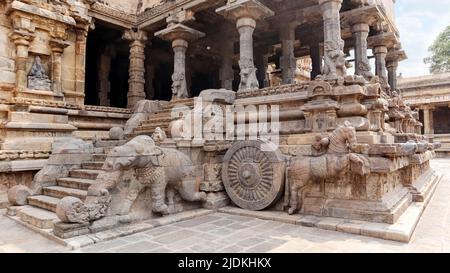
[[280, 24, 297, 84]]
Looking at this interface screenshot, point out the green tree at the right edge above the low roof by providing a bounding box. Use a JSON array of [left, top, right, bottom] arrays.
[[423, 26, 450, 74]]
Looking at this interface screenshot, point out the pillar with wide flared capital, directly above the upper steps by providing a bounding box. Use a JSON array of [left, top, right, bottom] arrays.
[[155, 22, 205, 99]]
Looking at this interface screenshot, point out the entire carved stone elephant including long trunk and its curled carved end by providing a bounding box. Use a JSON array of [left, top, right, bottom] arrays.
[[58, 136, 206, 222]]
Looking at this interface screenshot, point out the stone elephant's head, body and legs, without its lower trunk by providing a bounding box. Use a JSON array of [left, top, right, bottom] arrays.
[[88, 136, 206, 215]]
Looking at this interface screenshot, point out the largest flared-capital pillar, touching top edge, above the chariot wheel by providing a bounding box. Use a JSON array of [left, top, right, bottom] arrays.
[[216, 0, 274, 91]]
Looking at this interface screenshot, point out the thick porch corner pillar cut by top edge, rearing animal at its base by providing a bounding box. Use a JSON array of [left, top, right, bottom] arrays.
[[319, 0, 347, 80]]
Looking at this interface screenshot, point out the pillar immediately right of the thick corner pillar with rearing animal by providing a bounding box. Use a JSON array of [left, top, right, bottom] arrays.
[[352, 23, 373, 81]]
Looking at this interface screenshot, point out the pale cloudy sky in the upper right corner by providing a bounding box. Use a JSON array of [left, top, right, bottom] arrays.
[[396, 0, 450, 77]]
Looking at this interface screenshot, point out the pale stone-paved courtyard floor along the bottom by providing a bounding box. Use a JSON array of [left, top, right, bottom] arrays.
[[0, 159, 450, 253]]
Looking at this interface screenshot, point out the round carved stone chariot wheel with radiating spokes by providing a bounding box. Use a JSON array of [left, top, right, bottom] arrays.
[[222, 140, 285, 211]]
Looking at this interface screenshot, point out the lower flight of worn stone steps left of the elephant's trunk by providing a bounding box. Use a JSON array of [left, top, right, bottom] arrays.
[[16, 140, 119, 229]]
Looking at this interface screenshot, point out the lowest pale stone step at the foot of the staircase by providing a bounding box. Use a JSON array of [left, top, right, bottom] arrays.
[[17, 206, 59, 229]]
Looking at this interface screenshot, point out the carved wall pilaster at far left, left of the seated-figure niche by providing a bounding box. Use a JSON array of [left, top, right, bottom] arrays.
[[9, 30, 34, 90]]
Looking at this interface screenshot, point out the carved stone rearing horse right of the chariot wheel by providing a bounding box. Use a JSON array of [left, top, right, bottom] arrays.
[[284, 122, 370, 214]]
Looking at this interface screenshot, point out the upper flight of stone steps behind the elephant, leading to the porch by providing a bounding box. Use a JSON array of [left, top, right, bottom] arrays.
[[127, 98, 194, 138]]
